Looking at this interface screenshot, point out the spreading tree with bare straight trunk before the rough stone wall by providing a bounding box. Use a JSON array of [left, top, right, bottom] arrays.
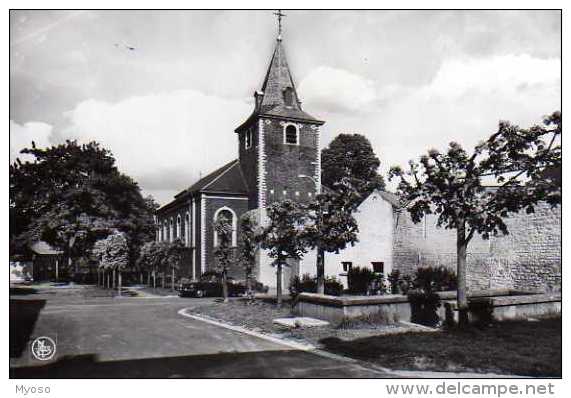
[[389, 112, 561, 327]]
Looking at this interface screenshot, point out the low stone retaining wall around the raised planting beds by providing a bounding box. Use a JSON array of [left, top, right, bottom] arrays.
[[294, 289, 561, 323]]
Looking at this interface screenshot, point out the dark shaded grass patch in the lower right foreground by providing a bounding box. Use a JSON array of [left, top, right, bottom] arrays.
[[320, 317, 561, 377]]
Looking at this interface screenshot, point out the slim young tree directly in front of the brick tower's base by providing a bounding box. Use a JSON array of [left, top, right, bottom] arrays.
[[261, 200, 307, 307]]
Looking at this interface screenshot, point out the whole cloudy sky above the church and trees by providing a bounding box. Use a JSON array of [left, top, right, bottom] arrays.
[[10, 10, 561, 204]]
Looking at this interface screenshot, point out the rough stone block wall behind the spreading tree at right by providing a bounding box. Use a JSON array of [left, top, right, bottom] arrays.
[[393, 204, 561, 290]]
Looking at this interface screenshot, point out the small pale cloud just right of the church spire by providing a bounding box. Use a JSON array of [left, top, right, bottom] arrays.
[[299, 66, 378, 113]]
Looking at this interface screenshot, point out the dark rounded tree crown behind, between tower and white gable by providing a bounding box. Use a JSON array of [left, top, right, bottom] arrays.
[[321, 134, 385, 197]]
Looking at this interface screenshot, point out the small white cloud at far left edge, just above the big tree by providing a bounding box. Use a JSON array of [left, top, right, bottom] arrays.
[[10, 120, 53, 163]]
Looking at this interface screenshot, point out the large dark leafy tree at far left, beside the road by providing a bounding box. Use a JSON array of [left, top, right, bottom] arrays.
[[10, 141, 156, 276]]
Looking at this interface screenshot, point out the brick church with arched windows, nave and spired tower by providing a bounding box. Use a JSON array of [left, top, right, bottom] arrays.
[[156, 24, 324, 286]]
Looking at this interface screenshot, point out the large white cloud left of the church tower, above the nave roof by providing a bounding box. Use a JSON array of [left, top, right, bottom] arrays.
[[63, 90, 252, 203]]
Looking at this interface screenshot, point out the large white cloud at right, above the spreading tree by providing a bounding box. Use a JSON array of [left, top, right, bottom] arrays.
[[361, 54, 561, 189]]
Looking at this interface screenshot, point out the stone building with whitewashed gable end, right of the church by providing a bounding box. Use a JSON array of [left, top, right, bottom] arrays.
[[325, 191, 561, 290]]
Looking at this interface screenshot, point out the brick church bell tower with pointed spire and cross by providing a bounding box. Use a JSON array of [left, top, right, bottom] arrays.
[[235, 12, 324, 209]]
